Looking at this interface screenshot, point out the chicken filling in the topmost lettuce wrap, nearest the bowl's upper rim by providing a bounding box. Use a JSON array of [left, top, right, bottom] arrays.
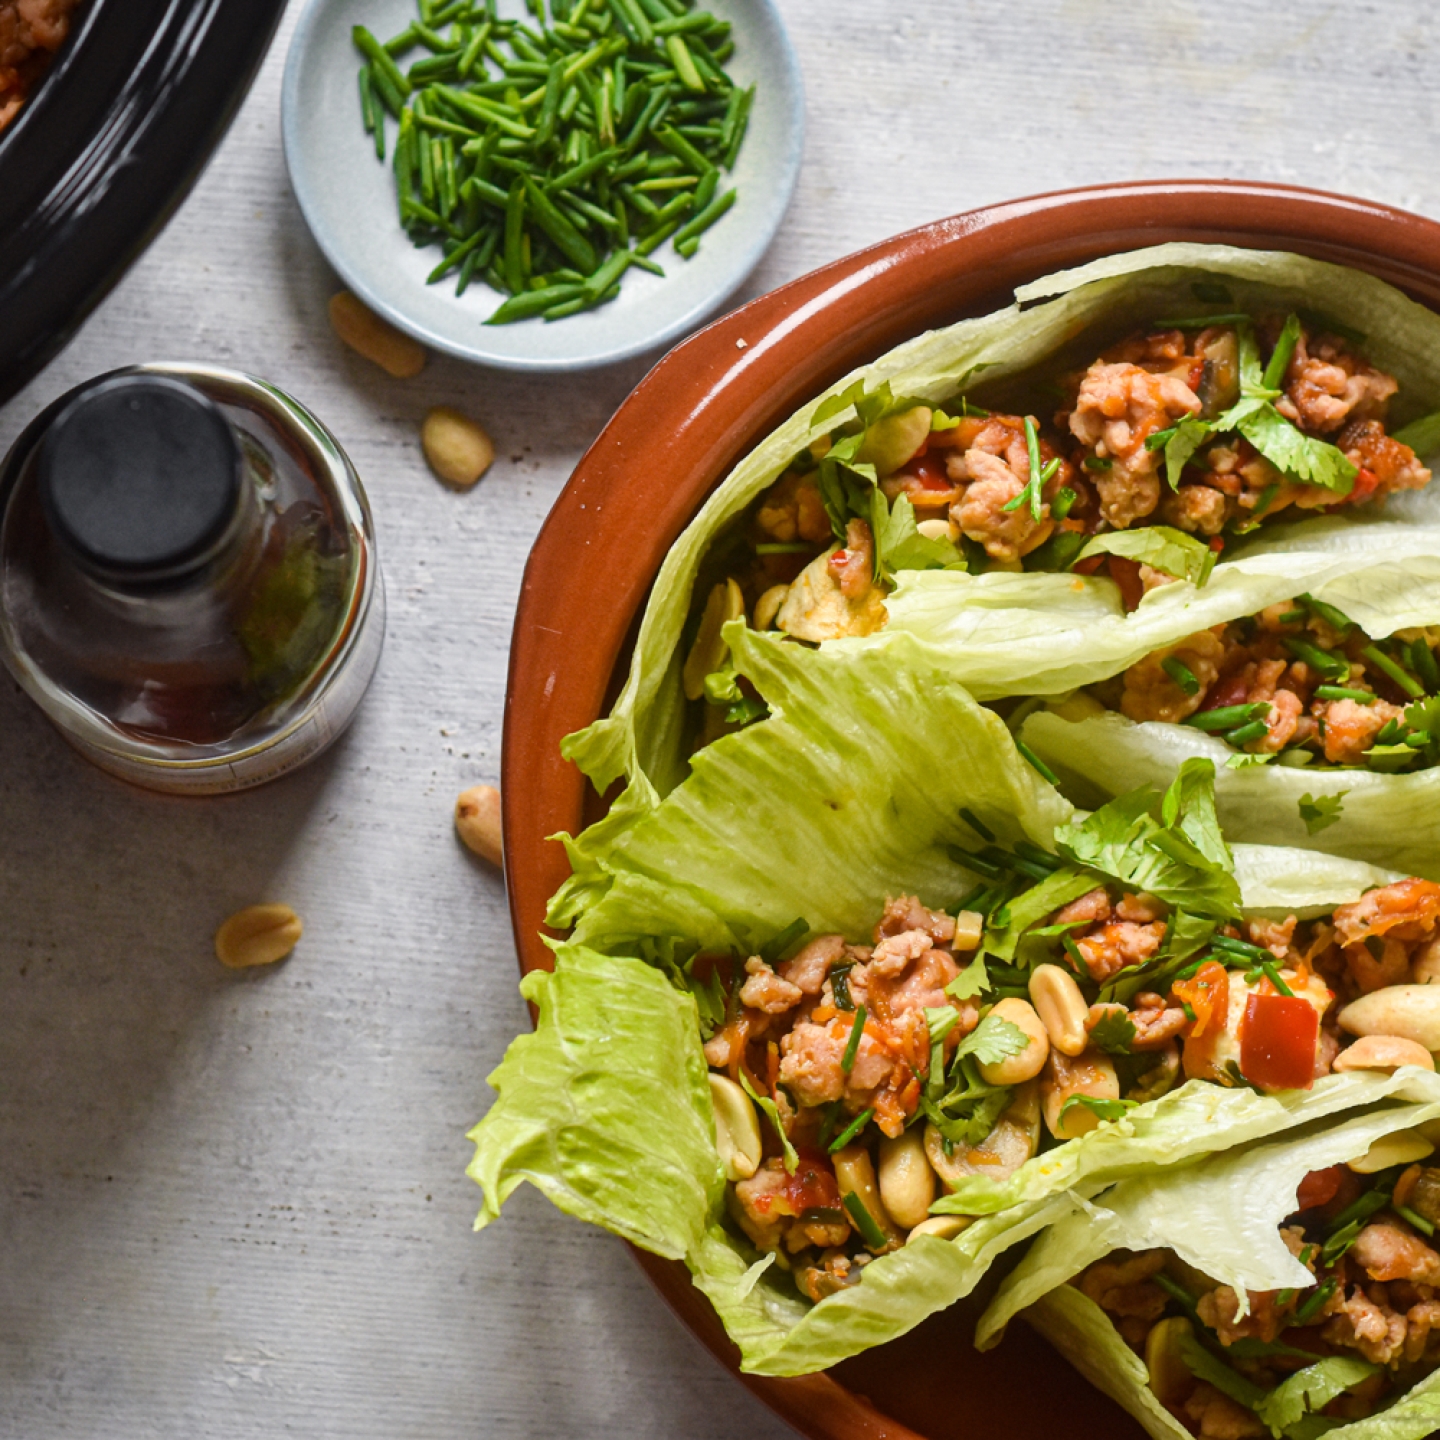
[[685, 315, 1430, 696]]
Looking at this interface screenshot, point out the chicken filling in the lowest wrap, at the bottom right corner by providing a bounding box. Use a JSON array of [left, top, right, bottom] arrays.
[[1071, 1157, 1440, 1440]]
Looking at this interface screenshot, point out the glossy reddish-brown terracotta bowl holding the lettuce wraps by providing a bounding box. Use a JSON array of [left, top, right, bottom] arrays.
[[503, 180, 1440, 1440]]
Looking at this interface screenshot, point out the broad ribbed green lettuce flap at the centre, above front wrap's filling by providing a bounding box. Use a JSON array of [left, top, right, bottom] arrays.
[[566, 622, 1070, 950]]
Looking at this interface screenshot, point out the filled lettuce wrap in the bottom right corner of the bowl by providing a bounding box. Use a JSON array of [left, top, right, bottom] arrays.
[[976, 1068, 1440, 1440]]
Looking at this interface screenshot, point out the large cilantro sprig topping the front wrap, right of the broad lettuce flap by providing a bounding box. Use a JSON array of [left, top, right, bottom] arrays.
[[1056, 757, 1240, 917]]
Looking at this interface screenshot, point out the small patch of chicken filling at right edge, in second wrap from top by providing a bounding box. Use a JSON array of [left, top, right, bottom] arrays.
[[1089, 595, 1440, 772]]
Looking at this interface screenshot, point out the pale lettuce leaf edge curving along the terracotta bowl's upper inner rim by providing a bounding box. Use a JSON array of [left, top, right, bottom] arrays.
[[566, 243, 1440, 809]]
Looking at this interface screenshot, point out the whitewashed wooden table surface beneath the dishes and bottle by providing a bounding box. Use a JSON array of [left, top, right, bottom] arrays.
[[0, 0, 1440, 1440]]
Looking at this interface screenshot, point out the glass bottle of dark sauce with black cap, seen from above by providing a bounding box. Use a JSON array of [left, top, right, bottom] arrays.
[[0, 364, 384, 793]]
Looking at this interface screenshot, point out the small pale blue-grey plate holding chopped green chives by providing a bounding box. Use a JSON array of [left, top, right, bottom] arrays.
[[281, 0, 805, 370]]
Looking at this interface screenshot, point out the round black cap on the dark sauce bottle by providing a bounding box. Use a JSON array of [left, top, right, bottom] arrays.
[[37, 373, 243, 586]]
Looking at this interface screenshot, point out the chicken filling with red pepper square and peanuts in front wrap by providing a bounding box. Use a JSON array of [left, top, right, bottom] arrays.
[[693, 864, 1440, 1300]]
